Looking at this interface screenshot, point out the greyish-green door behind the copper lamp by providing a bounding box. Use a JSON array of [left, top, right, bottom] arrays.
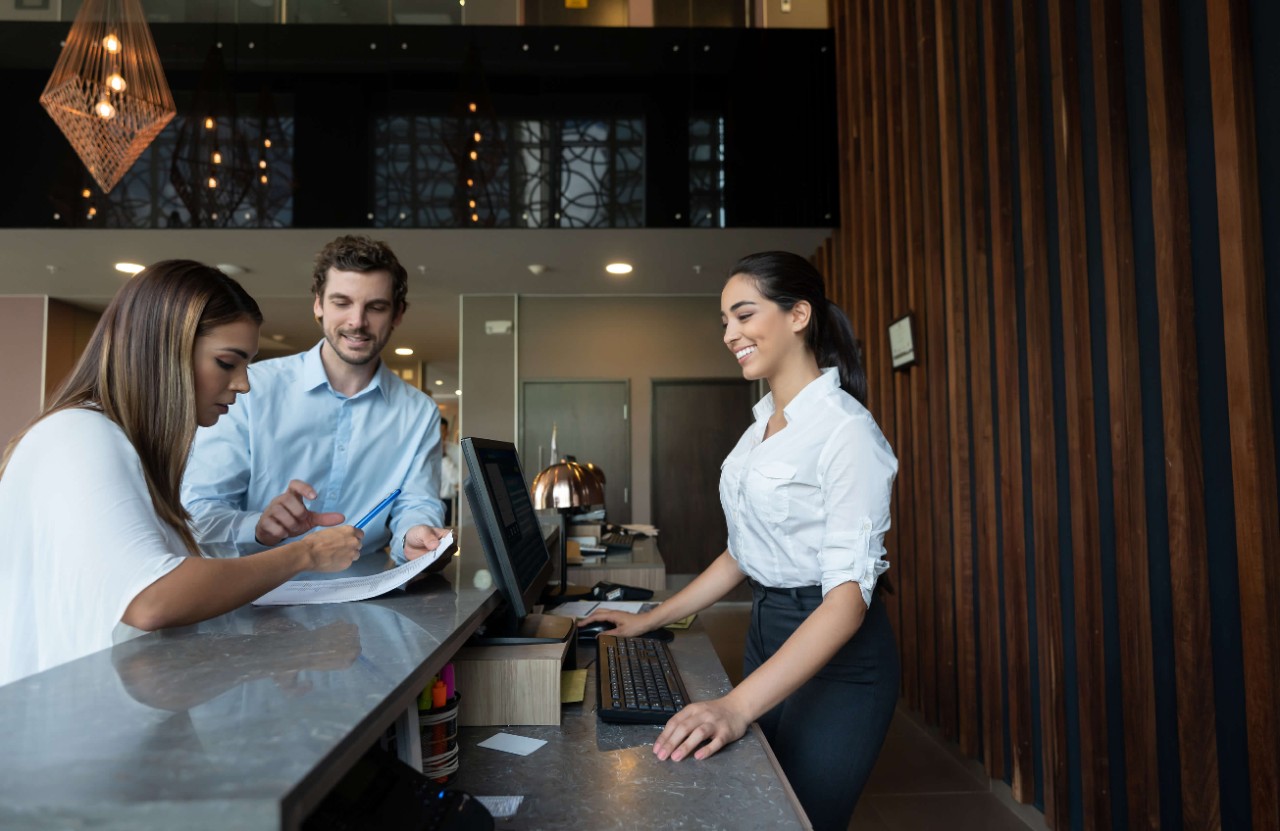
[[520, 380, 631, 522]]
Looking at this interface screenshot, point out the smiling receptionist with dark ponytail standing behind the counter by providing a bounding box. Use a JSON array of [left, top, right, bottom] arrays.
[[584, 251, 899, 830]]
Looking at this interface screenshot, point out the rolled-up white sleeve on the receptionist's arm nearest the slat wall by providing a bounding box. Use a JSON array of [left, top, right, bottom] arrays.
[[818, 417, 897, 607]]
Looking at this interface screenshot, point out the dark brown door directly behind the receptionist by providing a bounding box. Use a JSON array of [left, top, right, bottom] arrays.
[[652, 379, 756, 574]]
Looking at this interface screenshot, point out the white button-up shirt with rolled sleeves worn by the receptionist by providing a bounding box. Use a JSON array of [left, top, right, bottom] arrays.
[[721, 367, 897, 607]]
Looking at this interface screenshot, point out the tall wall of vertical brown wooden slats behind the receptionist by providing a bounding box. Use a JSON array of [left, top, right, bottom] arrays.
[[814, 0, 1280, 828]]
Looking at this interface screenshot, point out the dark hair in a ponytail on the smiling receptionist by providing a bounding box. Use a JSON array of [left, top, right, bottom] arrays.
[[730, 251, 867, 406]]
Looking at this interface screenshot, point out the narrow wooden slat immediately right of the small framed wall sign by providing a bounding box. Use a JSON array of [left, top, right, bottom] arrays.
[[913, 0, 956, 739]]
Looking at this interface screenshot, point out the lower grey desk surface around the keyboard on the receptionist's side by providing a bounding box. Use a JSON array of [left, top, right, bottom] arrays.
[[449, 622, 809, 831]]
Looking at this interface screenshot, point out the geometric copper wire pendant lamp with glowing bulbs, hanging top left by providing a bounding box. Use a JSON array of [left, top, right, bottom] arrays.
[[40, 0, 178, 193]]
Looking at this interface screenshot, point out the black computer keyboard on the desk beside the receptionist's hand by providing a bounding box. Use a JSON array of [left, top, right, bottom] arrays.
[[595, 634, 689, 725]]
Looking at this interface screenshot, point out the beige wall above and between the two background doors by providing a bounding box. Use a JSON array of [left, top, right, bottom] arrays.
[[517, 296, 740, 522]]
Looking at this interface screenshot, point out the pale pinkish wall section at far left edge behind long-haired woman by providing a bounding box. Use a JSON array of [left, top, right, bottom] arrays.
[[0, 296, 47, 452]]
